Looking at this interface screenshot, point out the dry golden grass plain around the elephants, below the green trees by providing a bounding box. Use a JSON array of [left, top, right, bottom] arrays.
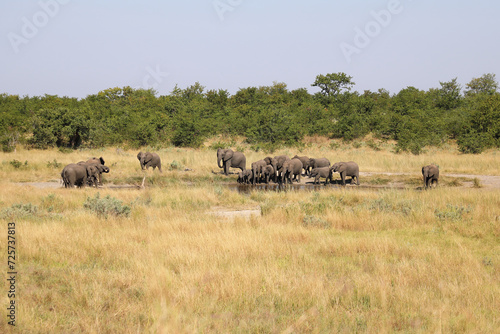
[[0, 139, 500, 333]]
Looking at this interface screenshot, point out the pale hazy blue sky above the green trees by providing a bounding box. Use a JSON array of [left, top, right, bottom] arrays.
[[0, 0, 500, 97]]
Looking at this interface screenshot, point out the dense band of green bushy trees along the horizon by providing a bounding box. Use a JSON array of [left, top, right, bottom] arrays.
[[0, 73, 500, 154]]
